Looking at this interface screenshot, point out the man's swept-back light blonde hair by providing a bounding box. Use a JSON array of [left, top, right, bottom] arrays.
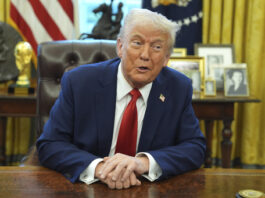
[[118, 8, 180, 53]]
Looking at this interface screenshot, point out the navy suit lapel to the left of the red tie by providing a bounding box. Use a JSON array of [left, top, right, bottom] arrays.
[[96, 58, 119, 156]]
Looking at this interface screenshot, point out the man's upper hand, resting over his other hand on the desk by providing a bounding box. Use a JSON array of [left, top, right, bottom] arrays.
[[98, 153, 149, 187]]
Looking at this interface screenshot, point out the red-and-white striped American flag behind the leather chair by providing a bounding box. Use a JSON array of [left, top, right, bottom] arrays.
[[9, 0, 74, 63]]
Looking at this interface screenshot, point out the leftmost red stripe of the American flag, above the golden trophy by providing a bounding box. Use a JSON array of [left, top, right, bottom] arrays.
[[10, 3, 38, 53]]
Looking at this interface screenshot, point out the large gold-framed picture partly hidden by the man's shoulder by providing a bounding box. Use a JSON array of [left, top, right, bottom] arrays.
[[168, 56, 204, 92]]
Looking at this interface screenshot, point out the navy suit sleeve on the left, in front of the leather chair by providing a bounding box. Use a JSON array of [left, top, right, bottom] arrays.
[[36, 72, 98, 182]]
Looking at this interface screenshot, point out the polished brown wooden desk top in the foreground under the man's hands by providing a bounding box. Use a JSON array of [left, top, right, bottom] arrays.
[[0, 167, 265, 198]]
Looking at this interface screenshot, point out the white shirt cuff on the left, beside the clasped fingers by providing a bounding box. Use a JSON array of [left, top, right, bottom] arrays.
[[79, 158, 103, 185]]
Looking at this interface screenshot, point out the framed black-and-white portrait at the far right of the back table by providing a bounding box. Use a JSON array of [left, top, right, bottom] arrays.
[[224, 67, 249, 97]]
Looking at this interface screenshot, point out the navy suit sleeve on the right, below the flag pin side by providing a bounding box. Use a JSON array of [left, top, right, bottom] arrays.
[[148, 85, 206, 180]]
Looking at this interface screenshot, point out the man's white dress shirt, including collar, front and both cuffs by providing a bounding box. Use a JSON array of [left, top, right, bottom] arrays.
[[79, 64, 162, 184]]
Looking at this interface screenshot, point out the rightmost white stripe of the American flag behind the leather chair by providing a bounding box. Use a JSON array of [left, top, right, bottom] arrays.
[[40, 0, 74, 39]]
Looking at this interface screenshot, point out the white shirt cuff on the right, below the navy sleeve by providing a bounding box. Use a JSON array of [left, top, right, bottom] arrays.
[[136, 152, 162, 182]]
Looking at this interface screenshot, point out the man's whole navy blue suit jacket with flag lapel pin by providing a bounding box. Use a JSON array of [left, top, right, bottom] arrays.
[[37, 58, 205, 182]]
